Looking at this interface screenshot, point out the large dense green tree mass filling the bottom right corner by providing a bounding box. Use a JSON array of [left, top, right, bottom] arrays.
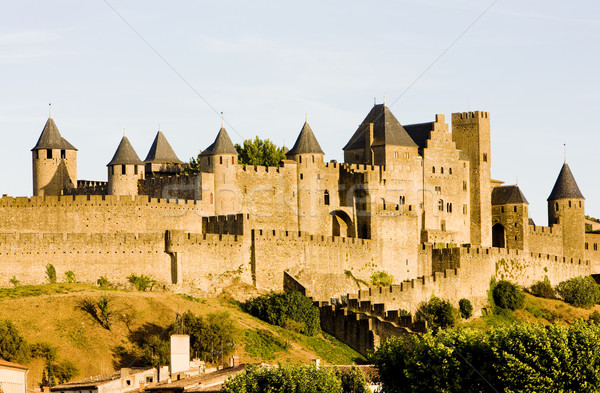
[[371, 321, 600, 393]]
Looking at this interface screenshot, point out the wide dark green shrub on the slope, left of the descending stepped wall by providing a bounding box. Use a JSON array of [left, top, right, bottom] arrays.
[[242, 290, 321, 336]]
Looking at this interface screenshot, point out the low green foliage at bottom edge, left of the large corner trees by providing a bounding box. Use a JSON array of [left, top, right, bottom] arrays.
[[221, 366, 343, 393]]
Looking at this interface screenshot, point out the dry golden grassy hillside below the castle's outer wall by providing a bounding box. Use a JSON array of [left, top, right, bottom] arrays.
[[0, 284, 362, 387]]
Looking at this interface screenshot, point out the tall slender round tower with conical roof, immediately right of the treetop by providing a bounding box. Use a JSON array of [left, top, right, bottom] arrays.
[[285, 122, 328, 233]]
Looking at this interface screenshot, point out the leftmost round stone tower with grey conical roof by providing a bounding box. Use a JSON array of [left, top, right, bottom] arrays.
[[31, 117, 77, 196]]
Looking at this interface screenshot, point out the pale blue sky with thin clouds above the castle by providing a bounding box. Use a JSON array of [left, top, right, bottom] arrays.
[[0, 0, 600, 225]]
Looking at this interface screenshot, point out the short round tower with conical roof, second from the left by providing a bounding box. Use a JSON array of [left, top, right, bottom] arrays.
[[106, 136, 144, 195]]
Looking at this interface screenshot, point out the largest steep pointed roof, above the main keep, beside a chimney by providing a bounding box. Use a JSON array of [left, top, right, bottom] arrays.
[[344, 104, 417, 150]]
